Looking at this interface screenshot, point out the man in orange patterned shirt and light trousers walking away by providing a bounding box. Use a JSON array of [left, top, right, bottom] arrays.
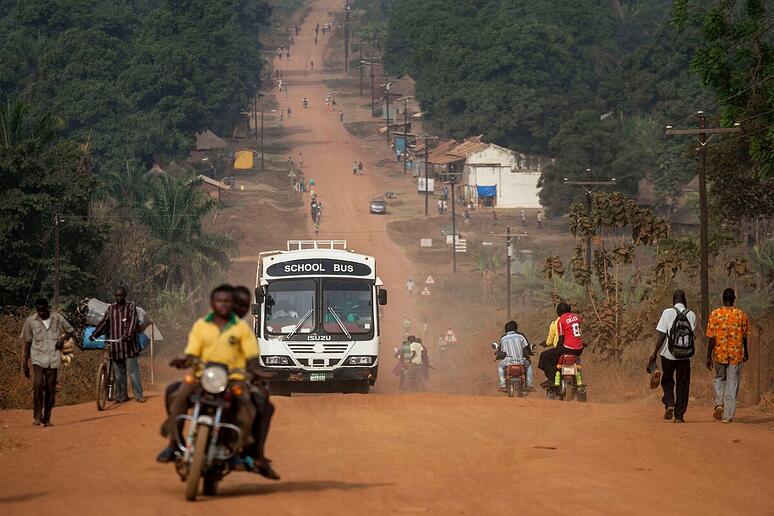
[[707, 288, 750, 423]]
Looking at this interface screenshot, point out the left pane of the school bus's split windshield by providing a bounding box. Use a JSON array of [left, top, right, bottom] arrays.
[[265, 279, 317, 335]]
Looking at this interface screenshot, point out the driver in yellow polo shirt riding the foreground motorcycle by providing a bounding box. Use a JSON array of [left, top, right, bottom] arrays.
[[157, 285, 260, 462]]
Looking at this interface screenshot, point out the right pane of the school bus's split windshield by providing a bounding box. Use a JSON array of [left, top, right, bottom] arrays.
[[322, 279, 374, 334]]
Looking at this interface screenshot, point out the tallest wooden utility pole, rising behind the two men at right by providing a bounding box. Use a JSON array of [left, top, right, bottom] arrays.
[[666, 111, 742, 325]]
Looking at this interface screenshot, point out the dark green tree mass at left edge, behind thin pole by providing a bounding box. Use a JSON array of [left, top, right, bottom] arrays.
[[0, 100, 103, 305]]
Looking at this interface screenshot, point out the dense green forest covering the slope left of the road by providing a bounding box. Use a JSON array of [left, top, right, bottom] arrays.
[[0, 0, 272, 305]]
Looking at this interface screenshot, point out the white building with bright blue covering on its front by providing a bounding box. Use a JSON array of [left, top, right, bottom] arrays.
[[464, 143, 550, 208]]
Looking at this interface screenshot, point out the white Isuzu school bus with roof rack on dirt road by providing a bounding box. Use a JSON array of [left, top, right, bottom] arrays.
[[253, 240, 387, 395]]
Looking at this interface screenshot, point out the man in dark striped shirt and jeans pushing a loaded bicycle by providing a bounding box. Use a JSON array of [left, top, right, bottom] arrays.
[[89, 287, 145, 403]]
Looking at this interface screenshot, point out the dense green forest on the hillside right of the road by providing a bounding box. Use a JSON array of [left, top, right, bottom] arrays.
[[379, 0, 774, 219]]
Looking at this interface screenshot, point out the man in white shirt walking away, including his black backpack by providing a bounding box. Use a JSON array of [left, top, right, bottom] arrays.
[[649, 290, 696, 423]]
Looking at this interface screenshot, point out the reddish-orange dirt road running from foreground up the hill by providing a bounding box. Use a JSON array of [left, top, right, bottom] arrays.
[[0, 0, 774, 516]]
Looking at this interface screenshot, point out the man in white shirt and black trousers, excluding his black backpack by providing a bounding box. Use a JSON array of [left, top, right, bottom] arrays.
[[650, 290, 696, 423]]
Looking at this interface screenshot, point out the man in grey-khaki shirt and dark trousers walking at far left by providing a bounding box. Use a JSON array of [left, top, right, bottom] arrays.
[[21, 298, 74, 426]]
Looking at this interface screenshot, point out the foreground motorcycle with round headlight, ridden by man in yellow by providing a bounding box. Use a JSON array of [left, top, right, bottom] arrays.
[[175, 363, 252, 501]]
